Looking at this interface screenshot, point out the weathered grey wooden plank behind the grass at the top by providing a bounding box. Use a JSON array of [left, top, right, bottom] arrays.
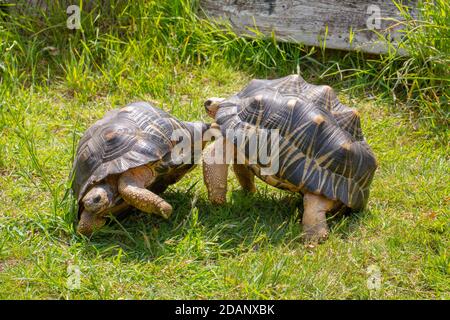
[[200, 0, 417, 53]]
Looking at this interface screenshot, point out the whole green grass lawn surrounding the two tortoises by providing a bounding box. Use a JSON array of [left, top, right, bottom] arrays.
[[0, 1, 450, 299]]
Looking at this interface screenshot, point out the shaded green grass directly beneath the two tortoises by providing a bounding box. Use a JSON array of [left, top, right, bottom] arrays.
[[75, 189, 363, 261]]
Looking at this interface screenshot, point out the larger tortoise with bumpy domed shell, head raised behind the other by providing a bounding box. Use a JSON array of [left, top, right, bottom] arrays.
[[203, 75, 377, 244]]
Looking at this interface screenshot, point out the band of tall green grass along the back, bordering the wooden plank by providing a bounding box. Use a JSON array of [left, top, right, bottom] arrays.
[[0, 0, 450, 128]]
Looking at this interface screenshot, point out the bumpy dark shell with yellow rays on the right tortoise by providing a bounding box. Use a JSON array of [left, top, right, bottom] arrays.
[[216, 75, 377, 210]]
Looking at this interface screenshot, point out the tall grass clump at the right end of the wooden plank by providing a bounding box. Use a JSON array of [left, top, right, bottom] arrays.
[[367, 0, 450, 126]]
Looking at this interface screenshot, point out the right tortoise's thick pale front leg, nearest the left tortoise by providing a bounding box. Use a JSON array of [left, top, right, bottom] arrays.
[[203, 140, 228, 204]]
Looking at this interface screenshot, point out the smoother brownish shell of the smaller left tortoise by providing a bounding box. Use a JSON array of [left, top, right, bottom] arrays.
[[72, 102, 206, 202]]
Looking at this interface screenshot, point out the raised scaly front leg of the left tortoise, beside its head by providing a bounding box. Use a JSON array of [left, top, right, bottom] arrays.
[[118, 166, 172, 219]]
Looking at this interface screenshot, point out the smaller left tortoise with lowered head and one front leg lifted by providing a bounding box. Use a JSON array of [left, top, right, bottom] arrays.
[[72, 102, 209, 236]]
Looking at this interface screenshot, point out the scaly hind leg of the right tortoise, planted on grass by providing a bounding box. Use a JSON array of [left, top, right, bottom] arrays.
[[302, 192, 338, 244]]
